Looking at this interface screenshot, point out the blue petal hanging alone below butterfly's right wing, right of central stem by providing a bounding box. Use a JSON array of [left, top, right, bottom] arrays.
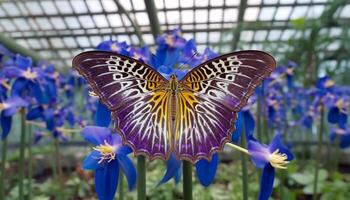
[[196, 154, 219, 187]]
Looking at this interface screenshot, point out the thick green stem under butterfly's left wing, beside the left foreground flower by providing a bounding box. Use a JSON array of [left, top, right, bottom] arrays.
[[137, 156, 146, 200]]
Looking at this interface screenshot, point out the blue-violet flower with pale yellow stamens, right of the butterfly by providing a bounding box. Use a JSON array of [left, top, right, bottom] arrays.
[[248, 134, 293, 200]]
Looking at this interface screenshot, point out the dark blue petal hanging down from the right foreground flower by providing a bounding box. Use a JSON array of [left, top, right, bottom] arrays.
[[258, 164, 275, 200]]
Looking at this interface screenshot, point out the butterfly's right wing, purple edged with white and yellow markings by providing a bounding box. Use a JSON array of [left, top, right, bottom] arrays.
[[174, 51, 276, 162]]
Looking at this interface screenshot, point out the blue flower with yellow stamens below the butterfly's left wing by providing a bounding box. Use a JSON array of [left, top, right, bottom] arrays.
[[82, 126, 136, 200]]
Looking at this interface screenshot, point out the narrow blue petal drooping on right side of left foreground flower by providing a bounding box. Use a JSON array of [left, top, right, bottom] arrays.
[[117, 155, 136, 190]]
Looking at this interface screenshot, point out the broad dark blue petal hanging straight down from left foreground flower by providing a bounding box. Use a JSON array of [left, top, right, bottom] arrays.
[[95, 160, 119, 200]]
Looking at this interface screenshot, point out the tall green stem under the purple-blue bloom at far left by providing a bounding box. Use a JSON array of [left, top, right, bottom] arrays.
[[18, 108, 26, 200]]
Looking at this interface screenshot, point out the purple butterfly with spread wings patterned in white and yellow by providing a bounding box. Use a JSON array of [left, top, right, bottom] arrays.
[[72, 50, 276, 163]]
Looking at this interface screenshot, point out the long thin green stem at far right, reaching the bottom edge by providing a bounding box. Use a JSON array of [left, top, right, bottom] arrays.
[[312, 105, 324, 200]]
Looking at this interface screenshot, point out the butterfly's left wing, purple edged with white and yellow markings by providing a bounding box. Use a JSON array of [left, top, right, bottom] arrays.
[[73, 51, 171, 159]]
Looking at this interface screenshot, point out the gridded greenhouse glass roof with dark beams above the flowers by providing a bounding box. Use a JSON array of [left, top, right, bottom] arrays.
[[0, 0, 350, 66]]
